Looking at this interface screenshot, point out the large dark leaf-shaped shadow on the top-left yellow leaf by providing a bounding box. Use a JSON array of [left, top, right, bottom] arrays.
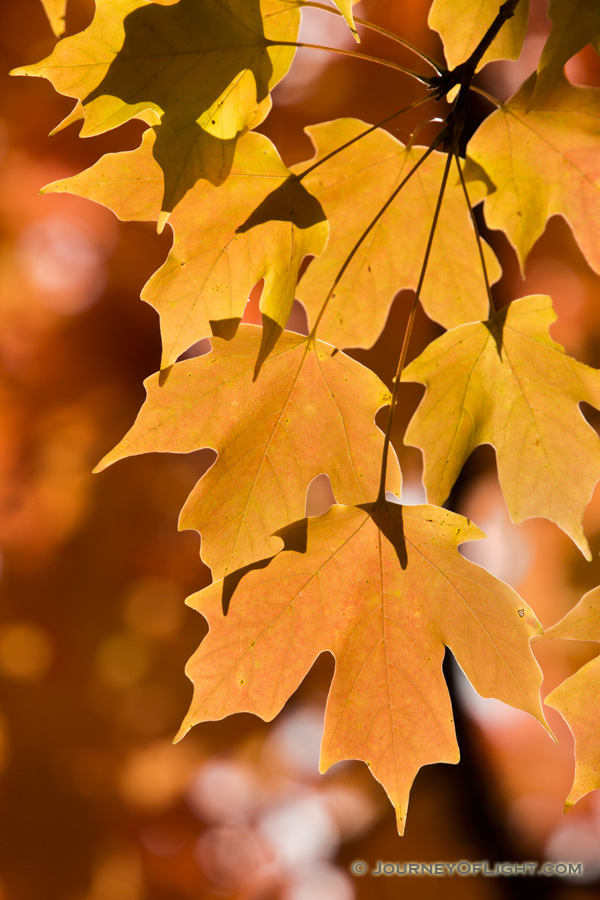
[[84, 0, 273, 212]]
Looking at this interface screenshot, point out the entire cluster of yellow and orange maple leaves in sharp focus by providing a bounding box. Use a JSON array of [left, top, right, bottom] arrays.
[[16, 0, 600, 832]]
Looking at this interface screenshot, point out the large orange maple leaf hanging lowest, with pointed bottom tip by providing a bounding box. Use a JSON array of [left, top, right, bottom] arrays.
[[178, 503, 544, 833]]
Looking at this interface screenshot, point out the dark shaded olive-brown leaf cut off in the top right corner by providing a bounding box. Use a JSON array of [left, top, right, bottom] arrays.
[[533, 0, 600, 103]]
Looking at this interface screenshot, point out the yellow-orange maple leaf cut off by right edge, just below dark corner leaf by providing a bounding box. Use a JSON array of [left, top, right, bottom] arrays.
[[469, 74, 600, 272]]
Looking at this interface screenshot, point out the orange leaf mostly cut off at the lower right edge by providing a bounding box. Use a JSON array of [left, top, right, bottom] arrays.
[[544, 588, 600, 812]]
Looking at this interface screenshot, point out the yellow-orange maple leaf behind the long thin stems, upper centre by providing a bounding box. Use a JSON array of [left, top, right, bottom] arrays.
[[294, 119, 501, 347]]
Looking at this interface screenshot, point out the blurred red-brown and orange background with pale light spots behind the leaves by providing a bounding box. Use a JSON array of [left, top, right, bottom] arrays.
[[0, 0, 600, 900]]
